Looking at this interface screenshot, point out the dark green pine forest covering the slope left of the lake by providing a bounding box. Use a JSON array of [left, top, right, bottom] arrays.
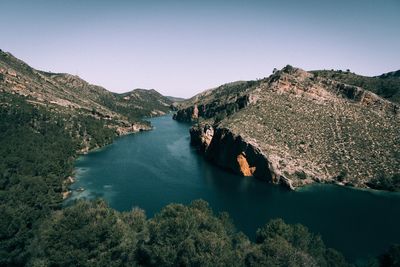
[[0, 93, 123, 266]]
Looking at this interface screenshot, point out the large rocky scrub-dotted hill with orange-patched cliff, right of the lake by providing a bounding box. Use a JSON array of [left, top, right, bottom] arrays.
[[174, 66, 400, 190]]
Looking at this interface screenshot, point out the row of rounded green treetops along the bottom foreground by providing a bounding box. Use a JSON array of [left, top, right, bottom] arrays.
[[29, 200, 348, 266]]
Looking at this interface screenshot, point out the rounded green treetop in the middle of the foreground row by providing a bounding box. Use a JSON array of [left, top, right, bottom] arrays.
[[140, 200, 241, 266]]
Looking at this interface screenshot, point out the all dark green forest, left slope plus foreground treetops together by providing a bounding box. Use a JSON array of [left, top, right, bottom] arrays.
[[0, 93, 356, 266]]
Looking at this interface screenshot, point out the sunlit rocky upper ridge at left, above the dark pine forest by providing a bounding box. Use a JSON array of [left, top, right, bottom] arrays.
[[0, 50, 172, 120]]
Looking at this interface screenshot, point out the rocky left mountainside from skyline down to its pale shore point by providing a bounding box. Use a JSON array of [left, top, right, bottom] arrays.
[[0, 50, 172, 151]]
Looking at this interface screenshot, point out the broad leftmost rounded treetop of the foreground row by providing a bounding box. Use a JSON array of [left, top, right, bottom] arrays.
[[31, 200, 147, 266]]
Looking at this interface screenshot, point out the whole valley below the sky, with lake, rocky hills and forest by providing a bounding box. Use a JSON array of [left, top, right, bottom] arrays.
[[0, 51, 400, 266]]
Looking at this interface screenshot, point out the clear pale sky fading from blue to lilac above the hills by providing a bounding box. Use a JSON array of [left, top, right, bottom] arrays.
[[0, 0, 400, 97]]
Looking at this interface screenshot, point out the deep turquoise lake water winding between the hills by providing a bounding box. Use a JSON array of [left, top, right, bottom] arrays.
[[67, 116, 400, 260]]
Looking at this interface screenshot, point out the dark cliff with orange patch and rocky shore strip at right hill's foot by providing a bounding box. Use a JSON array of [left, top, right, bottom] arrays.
[[182, 121, 399, 193]]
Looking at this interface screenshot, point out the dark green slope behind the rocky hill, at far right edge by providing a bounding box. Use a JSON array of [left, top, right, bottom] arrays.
[[313, 70, 400, 103]]
